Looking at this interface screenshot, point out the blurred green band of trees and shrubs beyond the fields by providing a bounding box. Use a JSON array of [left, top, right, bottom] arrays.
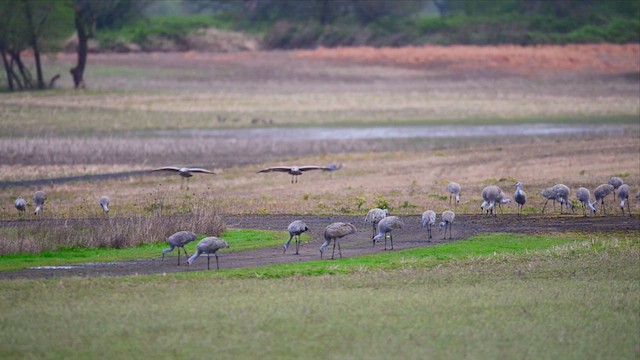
[[98, 0, 640, 49]]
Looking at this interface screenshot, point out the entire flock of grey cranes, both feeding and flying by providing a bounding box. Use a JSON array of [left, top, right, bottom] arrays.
[[7, 164, 640, 269]]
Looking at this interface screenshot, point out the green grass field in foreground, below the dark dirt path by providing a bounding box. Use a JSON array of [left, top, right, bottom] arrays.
[[0, 234, 640, 359]]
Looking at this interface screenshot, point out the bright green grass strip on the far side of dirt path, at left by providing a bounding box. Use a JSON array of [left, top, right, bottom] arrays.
[[0, 229, 288, 271]]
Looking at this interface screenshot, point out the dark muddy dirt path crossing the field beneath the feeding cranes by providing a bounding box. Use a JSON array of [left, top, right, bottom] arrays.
[[0, 214, 640, 279]]
